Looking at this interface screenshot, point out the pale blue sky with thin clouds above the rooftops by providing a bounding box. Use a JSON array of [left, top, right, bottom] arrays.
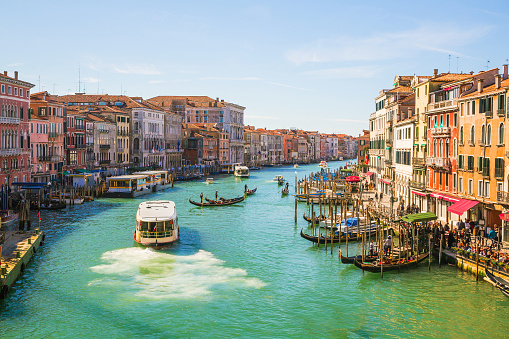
[[0, 0, 509, 136]]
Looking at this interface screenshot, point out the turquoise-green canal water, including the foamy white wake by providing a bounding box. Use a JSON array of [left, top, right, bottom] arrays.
[[0, 162, 509, 338]]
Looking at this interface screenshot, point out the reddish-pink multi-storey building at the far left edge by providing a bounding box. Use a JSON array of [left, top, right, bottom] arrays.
[[0, 72, 34, 185]]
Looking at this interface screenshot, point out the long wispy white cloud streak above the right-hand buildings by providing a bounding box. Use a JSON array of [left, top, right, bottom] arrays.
[[286, 23, 492, 65]]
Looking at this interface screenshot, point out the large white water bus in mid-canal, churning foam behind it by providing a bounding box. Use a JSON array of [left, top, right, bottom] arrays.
[[134, 200, 180, 247]]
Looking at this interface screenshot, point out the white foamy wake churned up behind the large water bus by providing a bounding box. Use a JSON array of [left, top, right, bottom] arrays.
[[90, 247, 266, 299]]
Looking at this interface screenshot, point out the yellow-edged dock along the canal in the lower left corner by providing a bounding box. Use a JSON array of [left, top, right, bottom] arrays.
[[0, 229, 44, 299]]
